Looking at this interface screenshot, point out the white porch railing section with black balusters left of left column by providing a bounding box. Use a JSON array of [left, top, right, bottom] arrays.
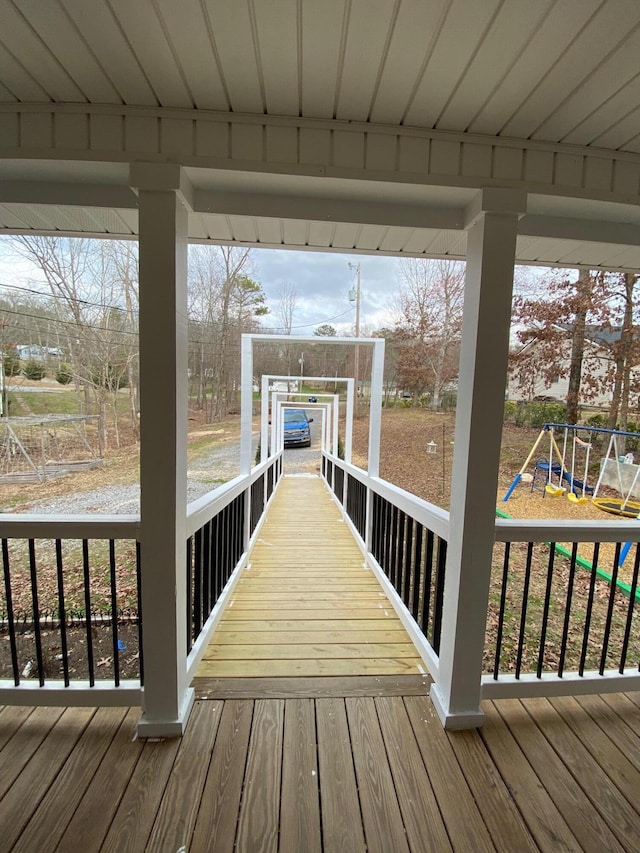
[[0, 514, 144, 705]]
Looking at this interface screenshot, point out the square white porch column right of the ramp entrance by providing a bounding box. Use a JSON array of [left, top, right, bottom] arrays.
[[431, 189, 526, 729]]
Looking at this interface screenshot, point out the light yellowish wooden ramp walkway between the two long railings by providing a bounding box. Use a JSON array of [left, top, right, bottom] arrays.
[[196, 477, 425, 686]]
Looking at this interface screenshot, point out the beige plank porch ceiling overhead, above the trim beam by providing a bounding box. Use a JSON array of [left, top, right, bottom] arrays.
[[0, 0, 640, 152]]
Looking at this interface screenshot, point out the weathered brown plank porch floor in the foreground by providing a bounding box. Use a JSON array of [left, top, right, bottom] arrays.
[[0, 694, 640, 853]]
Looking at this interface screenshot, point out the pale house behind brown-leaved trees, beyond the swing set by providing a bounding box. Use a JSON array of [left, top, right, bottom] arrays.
[[507, 328, 640, 408]]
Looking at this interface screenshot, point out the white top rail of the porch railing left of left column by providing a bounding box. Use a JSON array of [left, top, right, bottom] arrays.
[[0, 513, 140, 539]]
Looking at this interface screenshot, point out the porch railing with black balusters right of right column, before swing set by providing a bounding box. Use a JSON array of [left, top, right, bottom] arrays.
[[482, 519, 640, 698]]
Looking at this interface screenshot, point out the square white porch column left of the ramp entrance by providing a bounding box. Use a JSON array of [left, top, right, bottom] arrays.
[[130, 163, 193, 737]]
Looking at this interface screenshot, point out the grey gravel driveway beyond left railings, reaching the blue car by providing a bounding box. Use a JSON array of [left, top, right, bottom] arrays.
[[22, 412, 320, 515]]
